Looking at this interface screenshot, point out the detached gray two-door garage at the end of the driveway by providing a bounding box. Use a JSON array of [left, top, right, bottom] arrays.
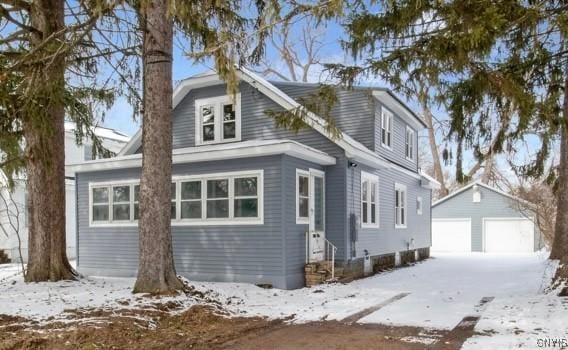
[[432, 182, 543, 253]]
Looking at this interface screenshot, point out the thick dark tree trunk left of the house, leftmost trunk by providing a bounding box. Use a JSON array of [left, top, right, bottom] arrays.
[[24, 0, 75, 282]]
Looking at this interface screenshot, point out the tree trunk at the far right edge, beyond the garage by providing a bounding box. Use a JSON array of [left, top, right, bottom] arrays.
[[550, 64, 568, 294]]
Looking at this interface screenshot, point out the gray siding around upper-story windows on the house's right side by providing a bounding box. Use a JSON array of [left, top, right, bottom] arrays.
[[374, 101, 418, 171]]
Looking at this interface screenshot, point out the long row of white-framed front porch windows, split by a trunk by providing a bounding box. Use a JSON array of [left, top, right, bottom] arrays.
[[90, 170, 264, 225]]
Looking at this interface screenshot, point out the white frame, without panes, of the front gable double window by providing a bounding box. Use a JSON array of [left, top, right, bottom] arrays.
[[195, 93, 241, 146]]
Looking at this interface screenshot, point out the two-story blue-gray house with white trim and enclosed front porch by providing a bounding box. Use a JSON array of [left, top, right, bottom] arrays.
[[69, 69, 437, 289]]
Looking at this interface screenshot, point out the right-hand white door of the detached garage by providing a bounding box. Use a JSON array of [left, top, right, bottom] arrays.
[[483, 218, 534, 253]]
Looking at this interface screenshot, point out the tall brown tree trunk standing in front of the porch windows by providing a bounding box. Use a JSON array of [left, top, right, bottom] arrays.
[[134, 0, 183, 293]]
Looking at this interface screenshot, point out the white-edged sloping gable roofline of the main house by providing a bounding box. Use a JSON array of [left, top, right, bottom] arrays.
[[118, 67, 421, 179]]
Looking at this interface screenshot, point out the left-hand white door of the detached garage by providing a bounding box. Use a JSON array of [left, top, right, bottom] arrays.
[[432, 218, 471, 252]]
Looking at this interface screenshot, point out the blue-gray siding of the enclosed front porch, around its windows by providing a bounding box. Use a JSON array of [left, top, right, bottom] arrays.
[[77, 156, 317, 288]]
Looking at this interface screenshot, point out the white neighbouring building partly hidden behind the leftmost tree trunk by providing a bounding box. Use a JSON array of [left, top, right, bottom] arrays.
[[0, 122, 130, 261]]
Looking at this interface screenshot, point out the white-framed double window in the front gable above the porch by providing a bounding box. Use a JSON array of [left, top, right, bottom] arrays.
[[195, 94, 241, 145]]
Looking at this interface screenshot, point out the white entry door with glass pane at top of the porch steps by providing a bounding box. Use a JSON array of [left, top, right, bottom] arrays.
[[309, 169, 325, 262]]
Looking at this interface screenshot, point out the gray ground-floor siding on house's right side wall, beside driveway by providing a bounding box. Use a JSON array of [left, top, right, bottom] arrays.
[[347, 165, 431, 258]]
